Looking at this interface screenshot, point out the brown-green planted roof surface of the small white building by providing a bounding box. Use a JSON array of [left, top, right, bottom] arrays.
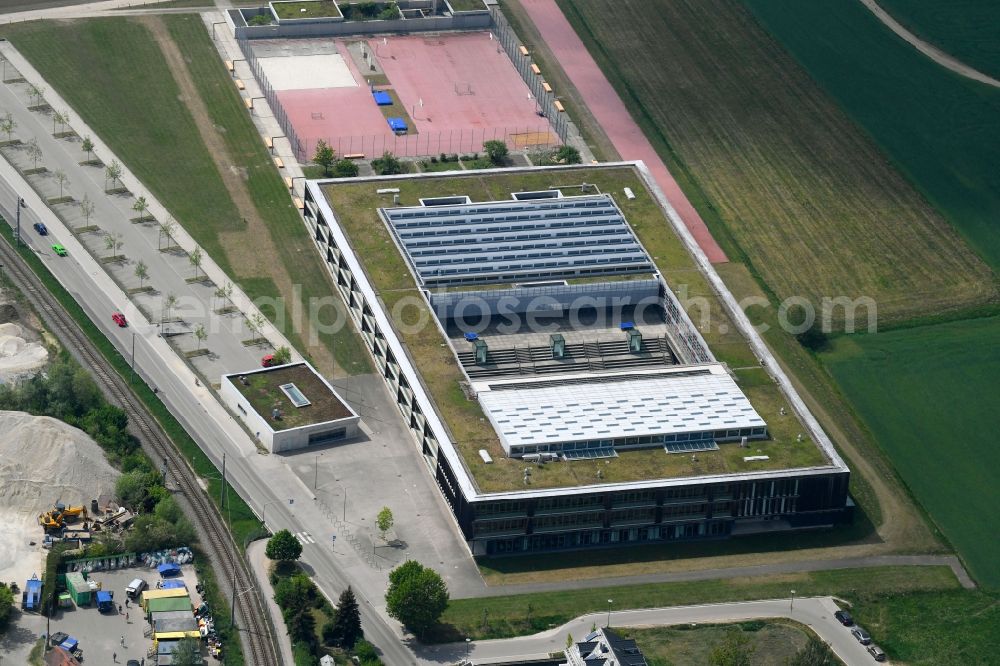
[[229, 363, 351, 431]]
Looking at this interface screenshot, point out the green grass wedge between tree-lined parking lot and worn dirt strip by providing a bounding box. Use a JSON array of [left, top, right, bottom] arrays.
[[0, 18, 239, 274]]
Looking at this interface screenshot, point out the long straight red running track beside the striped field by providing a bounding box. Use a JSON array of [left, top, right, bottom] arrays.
[[521, 0, 728, 263]]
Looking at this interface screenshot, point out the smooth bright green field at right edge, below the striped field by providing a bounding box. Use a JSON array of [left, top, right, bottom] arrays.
[[822, 317, 1000, 588]]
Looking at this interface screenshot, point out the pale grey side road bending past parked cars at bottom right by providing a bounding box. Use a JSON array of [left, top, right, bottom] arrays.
[[419, 597, 878, 666]]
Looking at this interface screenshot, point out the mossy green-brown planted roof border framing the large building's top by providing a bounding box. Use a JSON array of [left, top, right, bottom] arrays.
[[326, 168, 825, 492]]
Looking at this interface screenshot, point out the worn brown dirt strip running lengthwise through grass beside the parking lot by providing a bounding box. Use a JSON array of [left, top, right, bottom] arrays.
[[136, 16, 336, 372]]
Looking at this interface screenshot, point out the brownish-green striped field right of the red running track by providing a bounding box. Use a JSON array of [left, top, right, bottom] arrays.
[[559, 0, 995, 321]]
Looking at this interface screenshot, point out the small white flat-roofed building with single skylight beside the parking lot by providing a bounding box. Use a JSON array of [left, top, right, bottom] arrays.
[[220, 361, 361, 453]]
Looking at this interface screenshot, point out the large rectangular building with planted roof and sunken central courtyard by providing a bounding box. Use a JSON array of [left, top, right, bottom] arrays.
[[303, 163, 851, 555]]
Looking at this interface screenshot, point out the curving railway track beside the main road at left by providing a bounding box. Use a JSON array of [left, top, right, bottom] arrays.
[[0, 231, 280, 666]]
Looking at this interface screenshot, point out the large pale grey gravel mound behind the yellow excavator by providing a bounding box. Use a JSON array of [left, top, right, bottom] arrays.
[[0, 412, 118, 515]]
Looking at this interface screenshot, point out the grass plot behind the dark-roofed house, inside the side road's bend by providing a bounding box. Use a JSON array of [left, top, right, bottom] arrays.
[[624, 620, 815, 666]]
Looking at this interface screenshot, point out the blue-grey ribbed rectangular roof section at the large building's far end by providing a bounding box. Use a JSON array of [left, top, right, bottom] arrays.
[[383, 195, 654, 287]]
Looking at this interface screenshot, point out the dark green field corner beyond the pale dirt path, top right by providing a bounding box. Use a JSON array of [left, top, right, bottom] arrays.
[[879, 0, 1000, 79]]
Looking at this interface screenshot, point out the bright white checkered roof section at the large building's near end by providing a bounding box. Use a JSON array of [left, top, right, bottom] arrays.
[[474, 364, 766, 451]]
